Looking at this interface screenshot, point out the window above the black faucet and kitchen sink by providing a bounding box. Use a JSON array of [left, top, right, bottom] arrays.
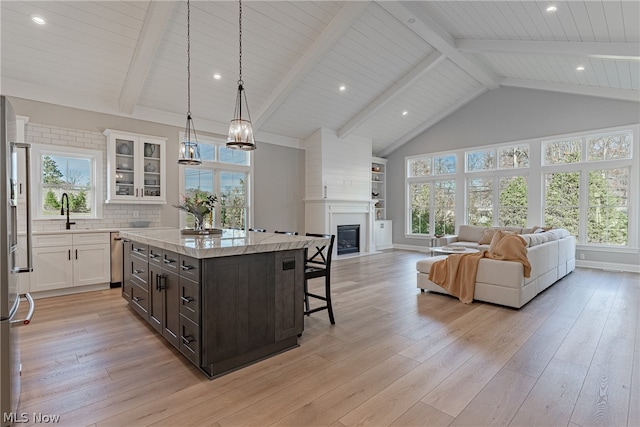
[[33, 145, 102, 219]]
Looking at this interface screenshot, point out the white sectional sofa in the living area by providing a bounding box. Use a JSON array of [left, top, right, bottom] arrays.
[[416, 225, 576, 308]]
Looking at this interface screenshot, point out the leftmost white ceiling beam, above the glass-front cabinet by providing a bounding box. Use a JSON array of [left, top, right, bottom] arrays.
[[118, 1, 179, 114]]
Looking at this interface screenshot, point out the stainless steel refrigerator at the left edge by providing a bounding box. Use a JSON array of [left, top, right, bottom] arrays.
[[0, 96, 35, 427]]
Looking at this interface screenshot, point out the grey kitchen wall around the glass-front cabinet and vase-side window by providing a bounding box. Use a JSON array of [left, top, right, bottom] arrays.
[[10, 97, 304, 231]]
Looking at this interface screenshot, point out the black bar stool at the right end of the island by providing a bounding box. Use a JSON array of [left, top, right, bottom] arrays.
[[304, 233, 336, 325]]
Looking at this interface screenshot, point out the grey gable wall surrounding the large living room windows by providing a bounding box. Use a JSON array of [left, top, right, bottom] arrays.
[[387, 88, 640, 265]]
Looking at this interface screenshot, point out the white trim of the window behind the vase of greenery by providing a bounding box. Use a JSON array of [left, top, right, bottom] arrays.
[[174, 132, 254, 227]]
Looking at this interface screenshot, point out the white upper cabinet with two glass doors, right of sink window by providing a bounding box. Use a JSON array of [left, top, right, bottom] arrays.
[[104, 129, 167, 204]]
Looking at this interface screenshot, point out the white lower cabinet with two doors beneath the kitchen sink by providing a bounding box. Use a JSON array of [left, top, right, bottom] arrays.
[[30, 233, 111, 292]]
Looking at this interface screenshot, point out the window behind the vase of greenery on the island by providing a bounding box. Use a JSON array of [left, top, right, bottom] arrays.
[[180, 142, 252, 229]]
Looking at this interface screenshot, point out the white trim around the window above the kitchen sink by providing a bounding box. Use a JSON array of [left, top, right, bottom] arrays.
[[31, 144, 104, 221]]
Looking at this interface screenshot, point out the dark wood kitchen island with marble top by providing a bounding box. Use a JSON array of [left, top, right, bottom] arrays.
[[120, 229, 328, 378]]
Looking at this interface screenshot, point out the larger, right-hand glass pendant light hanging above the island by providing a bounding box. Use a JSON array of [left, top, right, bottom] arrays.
[[227, 0, 256, 151]]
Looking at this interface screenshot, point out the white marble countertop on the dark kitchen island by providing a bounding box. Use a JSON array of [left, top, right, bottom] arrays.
[[120, 228, 329, 258]]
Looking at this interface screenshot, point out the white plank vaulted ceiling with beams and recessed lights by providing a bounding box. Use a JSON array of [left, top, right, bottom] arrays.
[[1, 0, 640, 156]]
